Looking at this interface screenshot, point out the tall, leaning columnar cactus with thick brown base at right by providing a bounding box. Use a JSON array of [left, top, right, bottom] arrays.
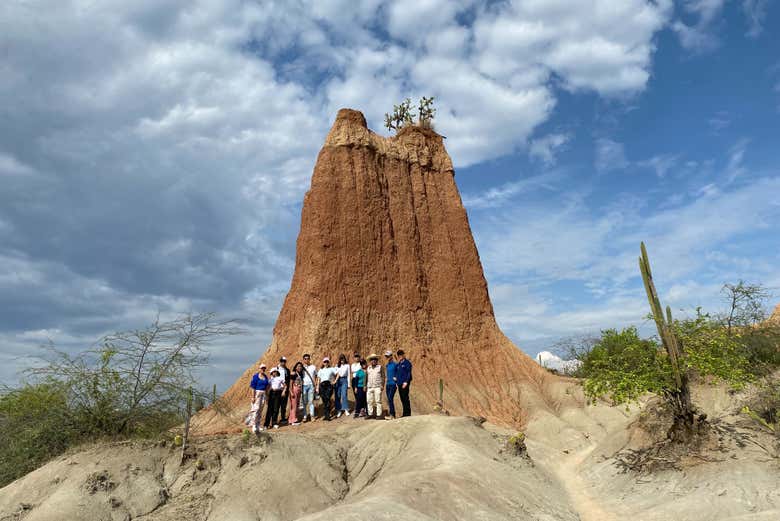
[[639, 242, 703, 435]]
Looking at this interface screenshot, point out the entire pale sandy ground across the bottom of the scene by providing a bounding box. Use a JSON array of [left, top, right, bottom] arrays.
[[0, 383, 780, 521]]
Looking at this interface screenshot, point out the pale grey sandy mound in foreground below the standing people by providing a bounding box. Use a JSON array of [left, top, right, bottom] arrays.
[[0, 416, 577, 521]]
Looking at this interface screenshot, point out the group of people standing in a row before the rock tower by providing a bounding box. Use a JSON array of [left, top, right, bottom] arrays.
[[245, 349, 412, 433]]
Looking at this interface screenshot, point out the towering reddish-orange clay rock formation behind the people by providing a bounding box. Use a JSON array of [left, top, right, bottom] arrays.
[[194, 109, 554, 434]]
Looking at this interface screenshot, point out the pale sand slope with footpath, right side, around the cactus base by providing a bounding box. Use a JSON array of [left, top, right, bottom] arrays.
[[516, 385, 780, 521]]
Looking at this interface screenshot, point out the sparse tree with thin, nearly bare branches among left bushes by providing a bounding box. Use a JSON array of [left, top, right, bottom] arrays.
[[28, 313, 242, 436]]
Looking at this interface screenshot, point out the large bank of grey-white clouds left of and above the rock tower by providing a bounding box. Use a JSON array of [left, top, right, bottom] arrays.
[[0, 0, 670, 388]]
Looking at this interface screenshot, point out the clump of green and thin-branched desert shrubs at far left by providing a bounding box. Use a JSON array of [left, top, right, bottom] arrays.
[[0, 313, 242, 486]]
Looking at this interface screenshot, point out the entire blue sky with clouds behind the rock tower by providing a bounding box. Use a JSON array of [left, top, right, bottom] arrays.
[[0, 0, 780, 389]]
